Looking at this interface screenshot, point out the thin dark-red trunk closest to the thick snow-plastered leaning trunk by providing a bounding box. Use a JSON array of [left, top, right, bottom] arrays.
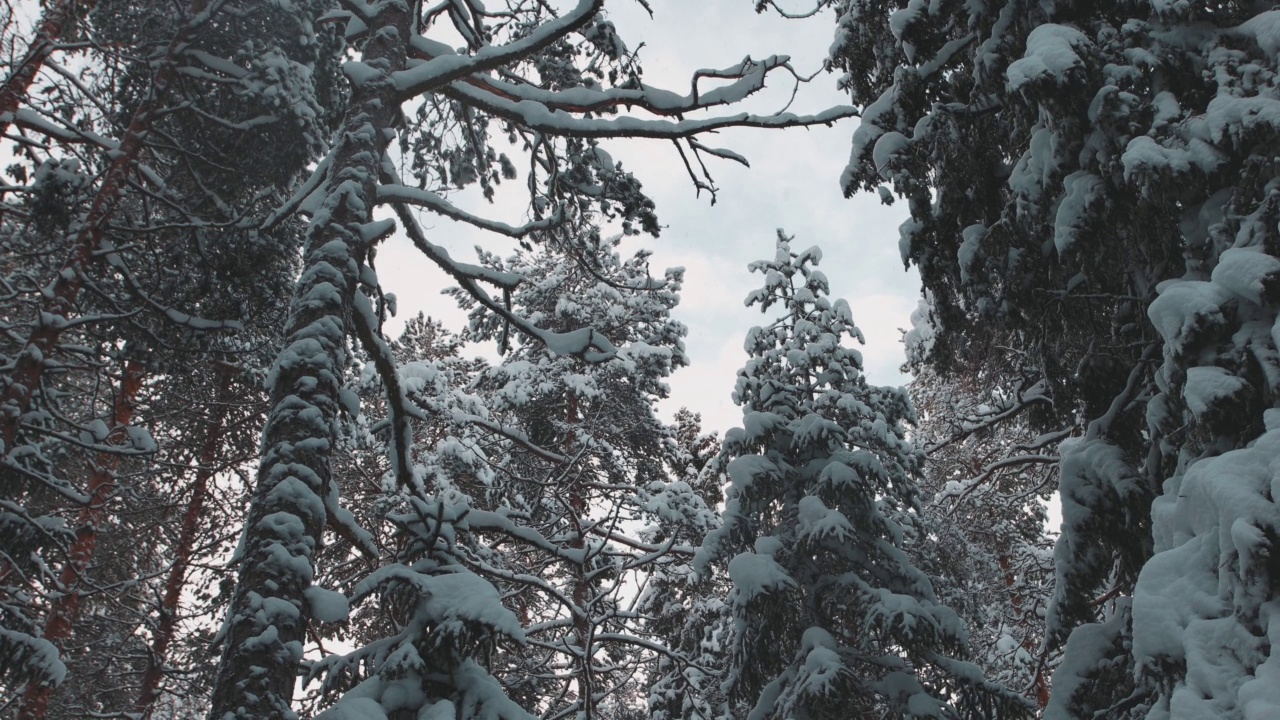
[[133, 376, 233, 720]]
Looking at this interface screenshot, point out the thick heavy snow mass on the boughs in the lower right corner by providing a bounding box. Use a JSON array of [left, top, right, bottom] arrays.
[[1133, 430, 1280, 719]]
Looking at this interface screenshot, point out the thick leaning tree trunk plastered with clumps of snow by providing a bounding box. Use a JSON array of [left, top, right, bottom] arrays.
[[209, 3, 411, 720]]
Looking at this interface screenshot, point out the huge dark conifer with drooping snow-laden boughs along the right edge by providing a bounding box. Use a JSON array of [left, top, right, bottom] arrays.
[[759, 0, 1277, 717]]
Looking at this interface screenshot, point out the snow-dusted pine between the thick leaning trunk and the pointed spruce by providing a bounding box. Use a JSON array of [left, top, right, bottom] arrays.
[[460, 238, 709, 717]]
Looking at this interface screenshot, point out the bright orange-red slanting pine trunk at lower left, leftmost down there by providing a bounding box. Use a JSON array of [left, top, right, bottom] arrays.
[[18, 361, 145, 720]]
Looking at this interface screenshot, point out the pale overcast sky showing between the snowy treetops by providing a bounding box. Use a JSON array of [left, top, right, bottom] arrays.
[[379, 0, 919, 433]]
